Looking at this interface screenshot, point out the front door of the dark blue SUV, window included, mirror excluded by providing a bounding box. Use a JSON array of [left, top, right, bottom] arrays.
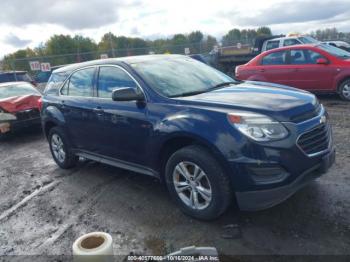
[[97, 66, 152, 165]]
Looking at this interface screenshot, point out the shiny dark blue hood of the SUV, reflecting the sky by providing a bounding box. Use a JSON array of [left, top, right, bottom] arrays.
[[179, 81, 319, 121]]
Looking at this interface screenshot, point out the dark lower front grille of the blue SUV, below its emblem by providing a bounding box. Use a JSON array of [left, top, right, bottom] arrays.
[[297, 124, 331, 155]]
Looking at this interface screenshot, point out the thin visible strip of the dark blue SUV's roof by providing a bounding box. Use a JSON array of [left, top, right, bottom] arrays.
[[54, 55, 187, 73]]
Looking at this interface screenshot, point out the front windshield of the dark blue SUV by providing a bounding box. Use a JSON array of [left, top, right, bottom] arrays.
[[131, 56, 238, 97]]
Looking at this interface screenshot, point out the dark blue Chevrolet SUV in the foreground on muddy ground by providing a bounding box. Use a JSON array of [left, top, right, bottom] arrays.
[[42, 55, 335, 219]]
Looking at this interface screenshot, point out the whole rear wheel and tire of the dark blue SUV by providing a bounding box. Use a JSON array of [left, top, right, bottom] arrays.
[[48, 127, 79, 169]]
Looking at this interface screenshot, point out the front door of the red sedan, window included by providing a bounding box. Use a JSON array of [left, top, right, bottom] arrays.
[[290, 49, 337, 91]]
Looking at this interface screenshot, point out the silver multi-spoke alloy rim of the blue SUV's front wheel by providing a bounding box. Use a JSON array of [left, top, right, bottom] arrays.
[[173, 162, 212, 210]]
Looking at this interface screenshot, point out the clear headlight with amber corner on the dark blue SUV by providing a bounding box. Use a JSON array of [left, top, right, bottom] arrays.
[[227, 113, 288, 141]]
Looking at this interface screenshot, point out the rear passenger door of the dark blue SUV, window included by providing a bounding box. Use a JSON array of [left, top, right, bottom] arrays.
[[60, 67, 103, 152]]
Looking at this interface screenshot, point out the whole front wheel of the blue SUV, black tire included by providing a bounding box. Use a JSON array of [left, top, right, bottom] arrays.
[[165, 145, 232, 220]]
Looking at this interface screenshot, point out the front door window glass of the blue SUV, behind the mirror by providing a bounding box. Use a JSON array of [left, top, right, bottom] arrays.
[[97, 66, 137, 98]]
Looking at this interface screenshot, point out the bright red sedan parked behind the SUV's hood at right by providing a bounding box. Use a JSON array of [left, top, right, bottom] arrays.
[[236, 44, 350, 101]]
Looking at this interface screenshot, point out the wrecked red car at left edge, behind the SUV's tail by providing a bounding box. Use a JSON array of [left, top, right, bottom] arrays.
[[0, 82, 41, 135]]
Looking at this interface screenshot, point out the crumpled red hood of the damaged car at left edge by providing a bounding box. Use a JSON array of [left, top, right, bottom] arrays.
[[0, 95, 41, 113]]
